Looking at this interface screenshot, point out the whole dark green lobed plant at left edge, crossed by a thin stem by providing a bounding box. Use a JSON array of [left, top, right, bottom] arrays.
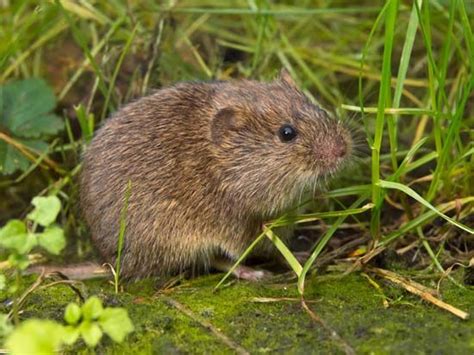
[[0, 78, 64, 175]]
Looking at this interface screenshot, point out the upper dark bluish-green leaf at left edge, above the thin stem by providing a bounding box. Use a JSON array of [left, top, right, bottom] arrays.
[[0, 78, 64, 138]]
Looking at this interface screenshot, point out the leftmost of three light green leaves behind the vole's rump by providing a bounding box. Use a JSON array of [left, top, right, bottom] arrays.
[[0, 219, 37, 254]]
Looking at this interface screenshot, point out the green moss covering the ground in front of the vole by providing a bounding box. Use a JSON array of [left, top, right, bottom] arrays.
[[8, 274, 474, 354]]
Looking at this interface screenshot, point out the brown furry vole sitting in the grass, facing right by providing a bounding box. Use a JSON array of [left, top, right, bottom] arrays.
[[80, 71, 352, 279]]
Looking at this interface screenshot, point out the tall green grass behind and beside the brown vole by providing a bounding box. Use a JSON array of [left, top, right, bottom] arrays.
[[0, 0, 474, 322]]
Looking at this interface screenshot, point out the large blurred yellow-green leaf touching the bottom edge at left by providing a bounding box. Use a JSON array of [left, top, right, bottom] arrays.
[[5, 319, 64, 355]]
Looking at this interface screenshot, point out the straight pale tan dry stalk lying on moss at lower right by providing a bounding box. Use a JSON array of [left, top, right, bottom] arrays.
[[366, 267, 469, 320]]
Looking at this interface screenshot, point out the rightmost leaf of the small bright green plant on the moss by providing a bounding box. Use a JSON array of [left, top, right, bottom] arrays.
[[99, 308, 134, 343]]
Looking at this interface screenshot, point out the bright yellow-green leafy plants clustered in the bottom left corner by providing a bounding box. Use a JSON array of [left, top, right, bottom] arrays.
[[5, 296, 134, 354]]
